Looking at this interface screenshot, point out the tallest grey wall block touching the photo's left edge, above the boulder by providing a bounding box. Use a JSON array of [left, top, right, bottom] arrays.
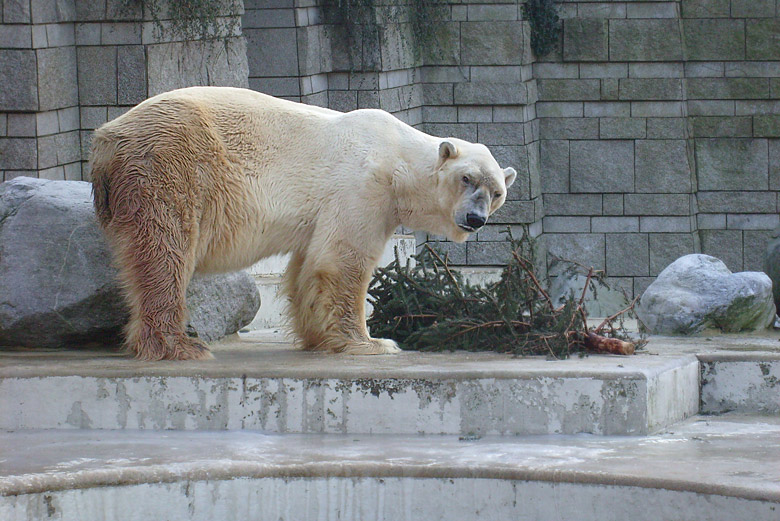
[[0, 49, 38, 111]]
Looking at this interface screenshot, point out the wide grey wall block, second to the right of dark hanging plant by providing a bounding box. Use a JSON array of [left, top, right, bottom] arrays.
[[609, 20, 682, 62]]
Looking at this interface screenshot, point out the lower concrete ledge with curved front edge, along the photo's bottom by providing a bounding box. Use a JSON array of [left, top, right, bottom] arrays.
[[0, 416, 780, 521]]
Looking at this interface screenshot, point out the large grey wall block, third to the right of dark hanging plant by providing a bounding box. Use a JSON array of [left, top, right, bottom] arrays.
[[683, 18, 745, 61]]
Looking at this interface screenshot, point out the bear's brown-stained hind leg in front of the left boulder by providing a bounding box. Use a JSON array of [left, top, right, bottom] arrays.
[[110, 193, 213, 360]]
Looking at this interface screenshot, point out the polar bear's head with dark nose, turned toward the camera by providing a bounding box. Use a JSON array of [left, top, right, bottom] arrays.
[[436, 138, 517, 242]]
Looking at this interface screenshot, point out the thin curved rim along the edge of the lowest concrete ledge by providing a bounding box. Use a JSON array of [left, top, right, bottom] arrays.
[[0, 462, 780, 504]]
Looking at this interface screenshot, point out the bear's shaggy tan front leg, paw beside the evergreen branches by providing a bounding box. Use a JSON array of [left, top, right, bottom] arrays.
[[289, 245, 401, 355]]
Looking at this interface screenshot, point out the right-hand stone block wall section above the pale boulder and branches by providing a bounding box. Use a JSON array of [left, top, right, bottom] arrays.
[[534, 0, 780, 294]]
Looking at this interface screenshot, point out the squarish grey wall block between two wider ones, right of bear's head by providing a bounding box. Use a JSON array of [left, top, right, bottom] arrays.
[[636, 139, 691, 193]]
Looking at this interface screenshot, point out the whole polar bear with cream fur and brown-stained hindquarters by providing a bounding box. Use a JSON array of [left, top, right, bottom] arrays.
[[90, 87, 516, 360]]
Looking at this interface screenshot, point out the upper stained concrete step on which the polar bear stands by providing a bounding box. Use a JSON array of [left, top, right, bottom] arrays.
[[0, 331, 700, 436]]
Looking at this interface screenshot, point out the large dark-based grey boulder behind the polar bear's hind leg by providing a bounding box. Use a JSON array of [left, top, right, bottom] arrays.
[[0, 177, 260, 348]]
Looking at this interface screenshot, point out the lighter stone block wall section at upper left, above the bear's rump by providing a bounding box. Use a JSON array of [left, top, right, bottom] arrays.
[[0, 0, 248, 181]]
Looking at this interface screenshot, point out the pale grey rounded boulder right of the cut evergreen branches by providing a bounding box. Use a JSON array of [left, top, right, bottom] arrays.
[[637, 254, 775, 335]]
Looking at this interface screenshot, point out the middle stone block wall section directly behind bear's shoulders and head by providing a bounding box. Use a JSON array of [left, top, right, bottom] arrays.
[[243, 0, 542, 266]]
